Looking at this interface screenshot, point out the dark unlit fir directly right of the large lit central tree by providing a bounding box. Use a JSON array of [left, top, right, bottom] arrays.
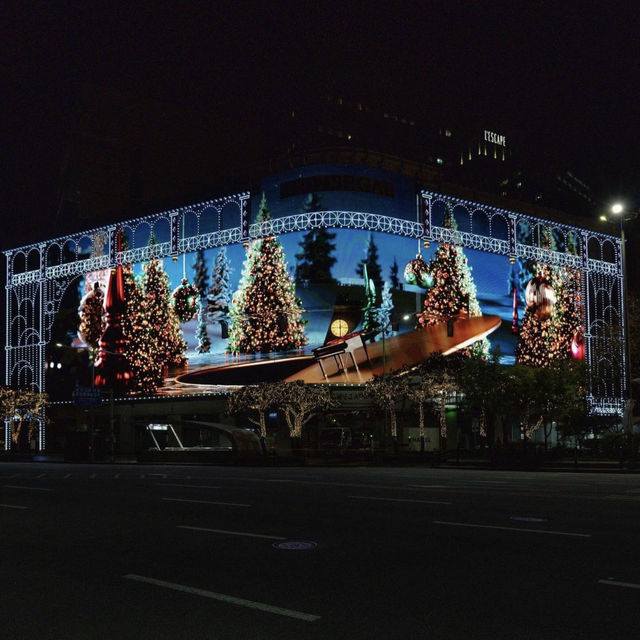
[[296, 193, 336, 283]]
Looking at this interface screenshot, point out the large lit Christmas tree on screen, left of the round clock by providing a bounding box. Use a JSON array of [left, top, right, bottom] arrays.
[[227, 194, 307, 353]]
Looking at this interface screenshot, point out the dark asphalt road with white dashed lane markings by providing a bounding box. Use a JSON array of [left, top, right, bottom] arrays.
[[0, 463, 640, 640]]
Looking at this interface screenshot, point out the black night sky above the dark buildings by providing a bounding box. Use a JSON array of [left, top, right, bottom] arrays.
[[0, 0, 640, 249]]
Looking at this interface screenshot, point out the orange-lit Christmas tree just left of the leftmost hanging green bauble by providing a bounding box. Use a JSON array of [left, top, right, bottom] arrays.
[[142, 258, 187, 367]]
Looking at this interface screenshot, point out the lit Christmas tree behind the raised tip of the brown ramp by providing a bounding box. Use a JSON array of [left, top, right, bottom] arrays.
[[417, 209, 490, 357]]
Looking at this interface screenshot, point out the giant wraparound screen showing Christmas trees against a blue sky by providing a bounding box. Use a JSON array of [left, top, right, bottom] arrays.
[[48, 202, 584, 396]]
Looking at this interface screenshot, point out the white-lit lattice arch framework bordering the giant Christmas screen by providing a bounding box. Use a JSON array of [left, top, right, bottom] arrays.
[[4, 185, 627, 449]]
